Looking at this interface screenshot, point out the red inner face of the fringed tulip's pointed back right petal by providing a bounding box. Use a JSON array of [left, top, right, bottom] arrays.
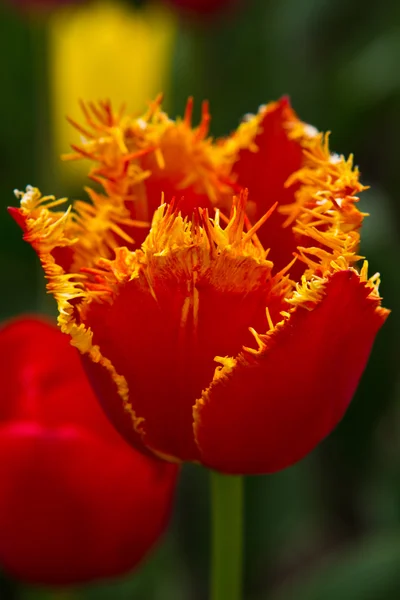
[[233, 98, 303, 271]]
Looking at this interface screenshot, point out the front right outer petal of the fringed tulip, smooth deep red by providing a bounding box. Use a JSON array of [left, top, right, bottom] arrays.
[[195, 271, 388, 474]]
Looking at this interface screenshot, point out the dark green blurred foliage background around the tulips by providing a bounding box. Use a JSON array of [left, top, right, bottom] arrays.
[[0, 0, 400, 600]]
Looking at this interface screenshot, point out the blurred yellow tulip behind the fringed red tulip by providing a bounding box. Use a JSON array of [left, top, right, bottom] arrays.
[[49, 0, 176, 177]]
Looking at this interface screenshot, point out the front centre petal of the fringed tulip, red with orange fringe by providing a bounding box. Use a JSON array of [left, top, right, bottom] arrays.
[[78, 195, 291, 461]]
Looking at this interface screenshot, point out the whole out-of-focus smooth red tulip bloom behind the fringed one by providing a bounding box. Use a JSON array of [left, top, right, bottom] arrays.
[[0, 318, 176, 585]]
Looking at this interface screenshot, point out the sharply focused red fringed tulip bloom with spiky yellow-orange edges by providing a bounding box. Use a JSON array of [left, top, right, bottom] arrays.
[[13, 99, 388, 473]]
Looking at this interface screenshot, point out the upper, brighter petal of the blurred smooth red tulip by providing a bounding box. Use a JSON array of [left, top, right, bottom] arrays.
[[0, 318, 117, 440]]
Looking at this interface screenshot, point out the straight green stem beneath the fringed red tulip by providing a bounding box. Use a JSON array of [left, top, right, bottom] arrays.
[[211, 471, 243, 600]]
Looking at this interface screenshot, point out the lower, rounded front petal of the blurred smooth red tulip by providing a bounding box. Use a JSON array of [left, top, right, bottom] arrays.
[[0, 422, 175, 585]]
